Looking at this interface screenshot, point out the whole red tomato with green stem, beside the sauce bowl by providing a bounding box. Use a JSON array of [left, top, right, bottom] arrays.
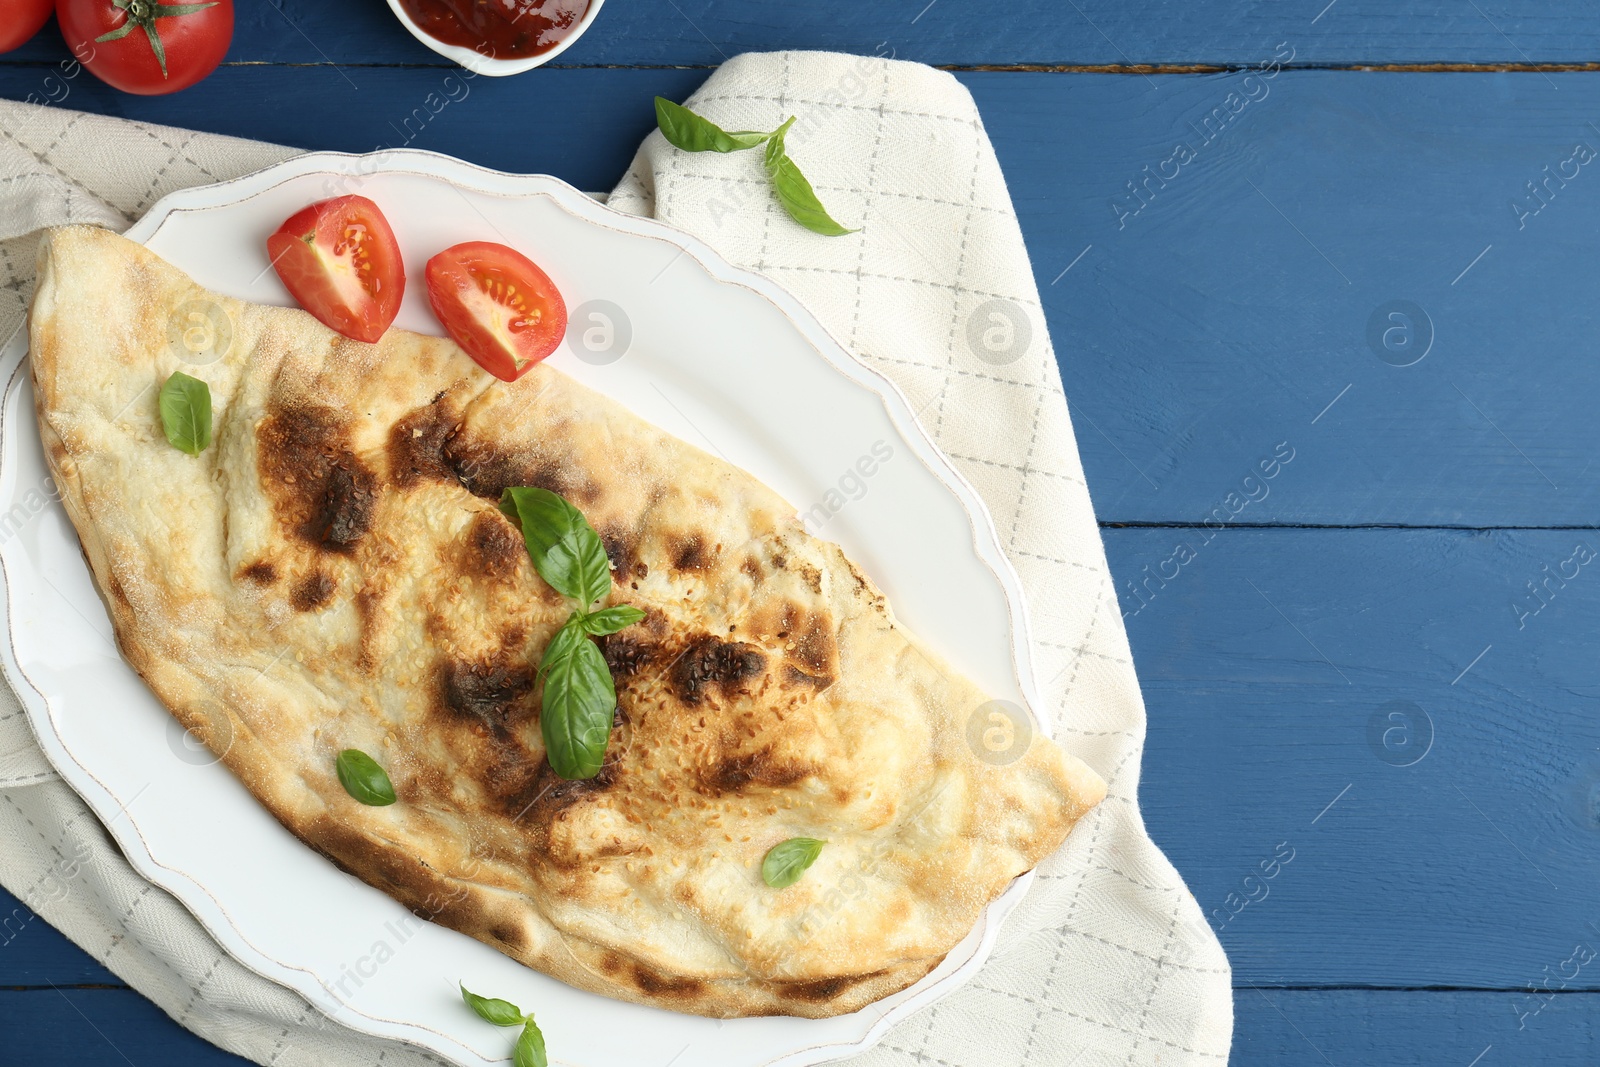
[[56, 0, 234, 96]]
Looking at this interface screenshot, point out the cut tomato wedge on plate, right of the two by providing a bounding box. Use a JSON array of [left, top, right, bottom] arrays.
[[427, 242, 566, 382]]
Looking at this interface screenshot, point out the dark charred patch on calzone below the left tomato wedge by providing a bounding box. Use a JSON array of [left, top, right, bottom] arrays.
[[256, 406, 378, 552]]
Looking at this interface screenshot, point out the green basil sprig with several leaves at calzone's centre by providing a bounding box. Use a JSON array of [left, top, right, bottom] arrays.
[[501, 486, 645, 779]]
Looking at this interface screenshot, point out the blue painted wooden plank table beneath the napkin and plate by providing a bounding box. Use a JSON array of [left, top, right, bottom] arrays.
[[0, 0, 1600, 1067]]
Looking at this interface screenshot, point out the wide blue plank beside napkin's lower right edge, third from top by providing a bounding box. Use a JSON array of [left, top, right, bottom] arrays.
[[1120, 530, 1600, 990]]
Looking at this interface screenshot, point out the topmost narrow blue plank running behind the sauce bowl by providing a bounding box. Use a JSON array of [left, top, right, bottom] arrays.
[[8, 0, 1600, 66]]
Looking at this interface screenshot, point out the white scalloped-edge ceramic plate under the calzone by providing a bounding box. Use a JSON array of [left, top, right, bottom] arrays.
[[0, 152, 1037, 1067]]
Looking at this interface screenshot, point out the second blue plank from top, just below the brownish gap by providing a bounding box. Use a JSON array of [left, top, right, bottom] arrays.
[[0, 67, 1600, 526]]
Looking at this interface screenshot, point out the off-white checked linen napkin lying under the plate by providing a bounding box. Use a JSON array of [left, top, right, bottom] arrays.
[[0, 53, 1232, 1067]]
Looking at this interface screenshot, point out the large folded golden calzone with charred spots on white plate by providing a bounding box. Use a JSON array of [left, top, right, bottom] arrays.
[[30, 227, 1104, 1017]]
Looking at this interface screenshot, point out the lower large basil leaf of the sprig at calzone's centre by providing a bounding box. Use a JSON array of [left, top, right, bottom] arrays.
[[539, 613, 616, 779]]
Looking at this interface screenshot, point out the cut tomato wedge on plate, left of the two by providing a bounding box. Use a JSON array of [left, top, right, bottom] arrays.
[[267, 197, 405, 344]]
